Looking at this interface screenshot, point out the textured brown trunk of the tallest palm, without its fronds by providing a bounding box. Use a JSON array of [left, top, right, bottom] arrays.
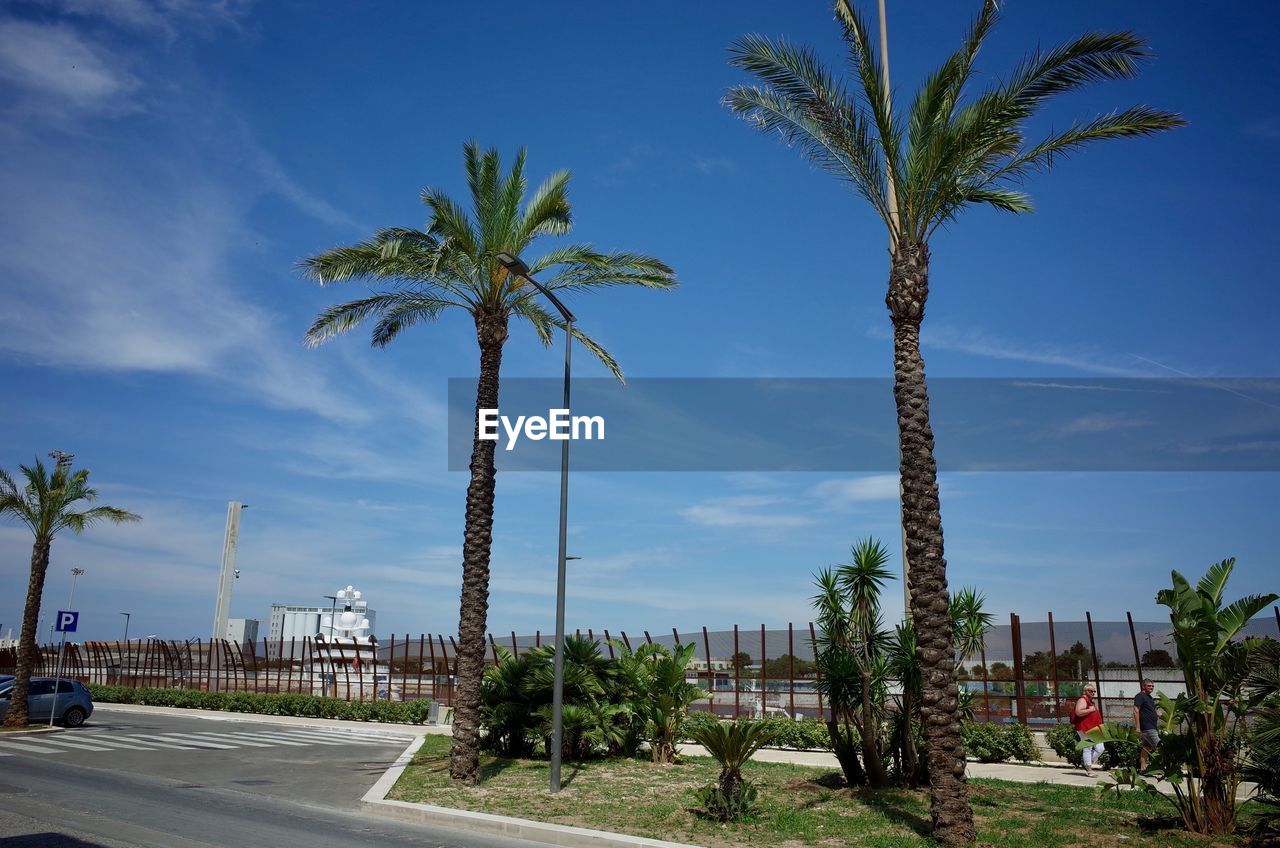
[[884, 242, 975, 847]]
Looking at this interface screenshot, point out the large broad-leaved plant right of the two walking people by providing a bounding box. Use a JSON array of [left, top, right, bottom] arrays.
[[1080, 559, 1280, 835]]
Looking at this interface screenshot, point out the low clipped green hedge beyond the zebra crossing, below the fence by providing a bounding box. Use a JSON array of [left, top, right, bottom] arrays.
[[88, 683, 431, 724]]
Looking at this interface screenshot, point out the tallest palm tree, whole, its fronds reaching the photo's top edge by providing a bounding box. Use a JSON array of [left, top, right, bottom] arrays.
[[726, 0, 1184, 845]]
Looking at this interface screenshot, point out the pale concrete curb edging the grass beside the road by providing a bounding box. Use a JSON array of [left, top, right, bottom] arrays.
[[360, 737, 696, 848]]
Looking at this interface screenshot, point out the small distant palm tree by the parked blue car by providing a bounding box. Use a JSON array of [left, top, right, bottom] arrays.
[[0, 459, 141, 728]]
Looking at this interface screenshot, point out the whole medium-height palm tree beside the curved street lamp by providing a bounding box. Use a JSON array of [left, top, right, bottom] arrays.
[[302, 141, 676, 783]]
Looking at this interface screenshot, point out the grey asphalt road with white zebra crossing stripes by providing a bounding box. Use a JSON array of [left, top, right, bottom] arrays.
[[0, 711, 535, 848]]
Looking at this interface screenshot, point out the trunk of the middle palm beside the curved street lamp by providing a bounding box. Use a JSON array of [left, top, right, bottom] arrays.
[[449, 313, 507, 784]]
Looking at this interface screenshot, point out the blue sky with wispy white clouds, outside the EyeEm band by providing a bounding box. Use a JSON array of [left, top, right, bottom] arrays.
[[0, 0, 1280, 638]]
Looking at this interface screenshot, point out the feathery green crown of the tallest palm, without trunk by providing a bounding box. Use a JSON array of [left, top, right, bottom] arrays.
[[727, 0, 1185, 246]]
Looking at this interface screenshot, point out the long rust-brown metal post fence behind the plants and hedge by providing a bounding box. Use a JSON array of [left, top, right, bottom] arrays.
[[0, 607, 1280, 725]]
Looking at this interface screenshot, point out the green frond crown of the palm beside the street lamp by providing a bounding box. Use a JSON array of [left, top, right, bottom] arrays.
[[301, 141, 676, 378]]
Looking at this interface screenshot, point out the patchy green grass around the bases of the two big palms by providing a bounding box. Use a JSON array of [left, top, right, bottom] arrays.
[[389, 737, 1244, 848]]
